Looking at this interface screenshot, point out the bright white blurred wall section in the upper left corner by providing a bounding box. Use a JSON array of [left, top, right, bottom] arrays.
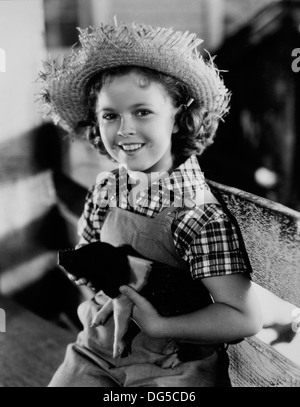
[[0, 0, 45, 142]]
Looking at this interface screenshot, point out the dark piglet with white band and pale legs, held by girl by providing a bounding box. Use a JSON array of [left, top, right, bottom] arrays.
[[58, 242, 211, 357]]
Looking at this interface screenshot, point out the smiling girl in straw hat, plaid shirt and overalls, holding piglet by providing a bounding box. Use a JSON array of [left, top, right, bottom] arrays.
[[42, 20, 262, 387]]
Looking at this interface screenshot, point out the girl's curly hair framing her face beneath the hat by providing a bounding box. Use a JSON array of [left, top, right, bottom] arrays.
[[76, 66, 219, 160]]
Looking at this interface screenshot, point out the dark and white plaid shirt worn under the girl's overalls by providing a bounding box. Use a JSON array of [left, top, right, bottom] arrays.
[[78, 156, 249, 278]]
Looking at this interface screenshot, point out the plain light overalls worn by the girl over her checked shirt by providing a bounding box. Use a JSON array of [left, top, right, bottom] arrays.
[[49, 193, 230, 387]]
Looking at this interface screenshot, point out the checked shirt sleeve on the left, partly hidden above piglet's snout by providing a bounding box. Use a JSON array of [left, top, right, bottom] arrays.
[[77, 185, 107, 246]]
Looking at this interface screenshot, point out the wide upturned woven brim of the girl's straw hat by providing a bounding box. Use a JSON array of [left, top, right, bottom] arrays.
[[39, 22, 229, 131]]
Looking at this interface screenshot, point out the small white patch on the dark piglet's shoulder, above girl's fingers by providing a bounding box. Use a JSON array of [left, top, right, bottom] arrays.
[[127, 256, 153, 291]]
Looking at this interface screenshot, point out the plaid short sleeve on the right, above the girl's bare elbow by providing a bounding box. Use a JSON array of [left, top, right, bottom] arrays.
[[172, 204, 252, 278]]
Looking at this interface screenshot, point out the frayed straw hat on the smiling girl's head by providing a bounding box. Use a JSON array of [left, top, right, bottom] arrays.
[[40, 21, 230, 132]]
